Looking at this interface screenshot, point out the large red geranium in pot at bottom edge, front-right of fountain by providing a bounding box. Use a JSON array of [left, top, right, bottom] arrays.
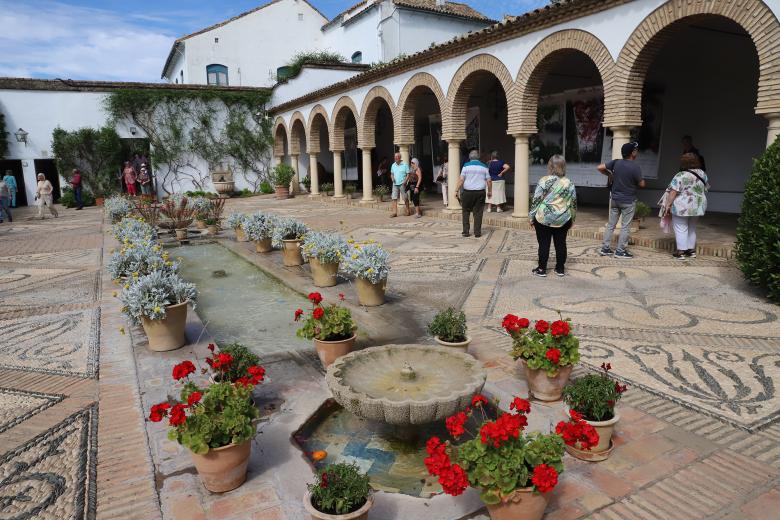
[[425, 395, 564, 520]]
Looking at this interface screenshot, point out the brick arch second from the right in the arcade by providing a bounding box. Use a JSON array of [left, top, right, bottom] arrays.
[[509, 29, 615, 134]]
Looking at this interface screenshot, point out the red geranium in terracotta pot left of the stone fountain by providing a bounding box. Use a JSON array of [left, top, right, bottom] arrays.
[[149, 352, 265, 493]]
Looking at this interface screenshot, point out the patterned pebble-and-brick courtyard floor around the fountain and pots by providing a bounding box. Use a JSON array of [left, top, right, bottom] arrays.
[[0, 196, 780, 520]]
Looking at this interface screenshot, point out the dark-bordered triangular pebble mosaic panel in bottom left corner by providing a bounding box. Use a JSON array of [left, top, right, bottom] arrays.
[[0, 405, 98, 520]]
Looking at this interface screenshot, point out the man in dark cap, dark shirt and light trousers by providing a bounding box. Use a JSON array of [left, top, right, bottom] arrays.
[[598, 143, 645, 259]]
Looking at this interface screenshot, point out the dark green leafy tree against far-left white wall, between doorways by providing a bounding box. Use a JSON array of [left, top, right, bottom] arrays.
[[52, 126, 122, 197]]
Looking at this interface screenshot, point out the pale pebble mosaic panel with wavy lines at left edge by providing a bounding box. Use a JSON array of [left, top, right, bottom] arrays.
[[0, 309, 100, 377]]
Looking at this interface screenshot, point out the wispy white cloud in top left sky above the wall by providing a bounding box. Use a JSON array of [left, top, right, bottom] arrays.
[[0, 0, 174, 82]]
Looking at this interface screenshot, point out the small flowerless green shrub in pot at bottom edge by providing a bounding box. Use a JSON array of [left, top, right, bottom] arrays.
[[308, 462, 371, 515]]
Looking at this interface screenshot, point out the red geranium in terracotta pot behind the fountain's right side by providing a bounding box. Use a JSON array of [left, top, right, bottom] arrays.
[[501, 314, 580, 401]]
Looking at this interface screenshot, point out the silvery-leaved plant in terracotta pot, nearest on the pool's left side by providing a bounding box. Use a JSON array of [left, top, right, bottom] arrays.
[[120, 271, 198, 352]]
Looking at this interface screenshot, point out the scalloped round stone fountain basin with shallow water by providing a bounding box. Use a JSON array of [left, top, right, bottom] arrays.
[[326, 345, 486, 426]]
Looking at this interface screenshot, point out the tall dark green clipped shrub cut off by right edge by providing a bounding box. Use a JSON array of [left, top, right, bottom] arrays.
[[736, 139, 780, 302]]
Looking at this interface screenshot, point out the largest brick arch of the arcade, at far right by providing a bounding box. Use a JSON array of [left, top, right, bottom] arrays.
[[605, 0, 780, 126]]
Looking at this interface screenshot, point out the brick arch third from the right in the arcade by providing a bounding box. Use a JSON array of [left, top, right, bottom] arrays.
[[442, 54, 517, 140]]
